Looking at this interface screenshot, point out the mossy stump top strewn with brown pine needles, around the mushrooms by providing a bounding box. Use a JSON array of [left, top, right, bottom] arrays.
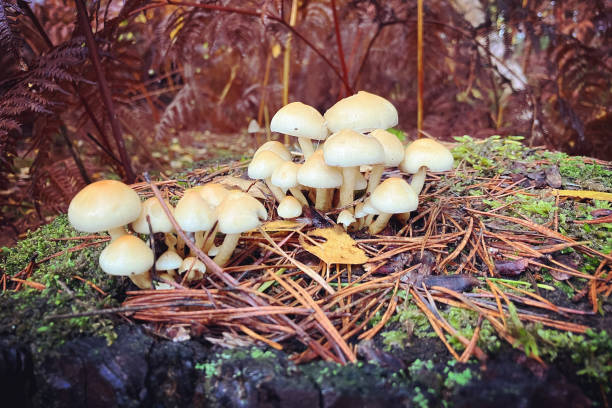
[[0, 137, 612, 407]]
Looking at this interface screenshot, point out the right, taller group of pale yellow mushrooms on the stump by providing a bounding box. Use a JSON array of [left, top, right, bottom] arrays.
[[248, 91, 453, 234]]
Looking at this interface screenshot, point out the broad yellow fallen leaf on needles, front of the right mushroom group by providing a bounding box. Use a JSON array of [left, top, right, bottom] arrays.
[[300, 227, 368, 265]]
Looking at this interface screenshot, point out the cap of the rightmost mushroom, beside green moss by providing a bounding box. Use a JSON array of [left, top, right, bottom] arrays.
[[400, 138, 453, 174]]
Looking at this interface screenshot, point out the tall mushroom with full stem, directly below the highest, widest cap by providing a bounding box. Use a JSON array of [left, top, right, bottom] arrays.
[[323, 129, 385, 207]]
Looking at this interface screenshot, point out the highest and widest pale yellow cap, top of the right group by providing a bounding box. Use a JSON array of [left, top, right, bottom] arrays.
[[324, 91, 398, 132]]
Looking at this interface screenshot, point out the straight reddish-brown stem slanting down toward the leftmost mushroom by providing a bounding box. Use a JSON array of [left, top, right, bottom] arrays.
[[75, 0, 136, 183]]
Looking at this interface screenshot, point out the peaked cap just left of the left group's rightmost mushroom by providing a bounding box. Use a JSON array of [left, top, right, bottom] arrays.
[[174, 189, 217, 232]]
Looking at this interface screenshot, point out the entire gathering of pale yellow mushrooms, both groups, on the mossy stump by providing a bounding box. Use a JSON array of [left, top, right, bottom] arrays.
[[68, 91, 453, 288]]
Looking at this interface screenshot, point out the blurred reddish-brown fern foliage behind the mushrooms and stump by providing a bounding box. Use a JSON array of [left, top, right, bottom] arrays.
[[0, 0, 612, 241]]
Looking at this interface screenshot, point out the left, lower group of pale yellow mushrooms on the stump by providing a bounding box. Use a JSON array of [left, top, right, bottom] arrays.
[[68, 180, 270, 289]]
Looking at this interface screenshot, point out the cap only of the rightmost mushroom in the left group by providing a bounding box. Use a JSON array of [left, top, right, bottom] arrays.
[[216, 191, 268, 234]]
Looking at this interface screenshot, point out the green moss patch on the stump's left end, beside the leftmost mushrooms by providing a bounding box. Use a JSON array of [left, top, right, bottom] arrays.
[[0, 215, 121, 352]]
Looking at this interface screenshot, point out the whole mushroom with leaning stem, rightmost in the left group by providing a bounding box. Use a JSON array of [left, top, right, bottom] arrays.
[[214, 191, 268, 266]]
